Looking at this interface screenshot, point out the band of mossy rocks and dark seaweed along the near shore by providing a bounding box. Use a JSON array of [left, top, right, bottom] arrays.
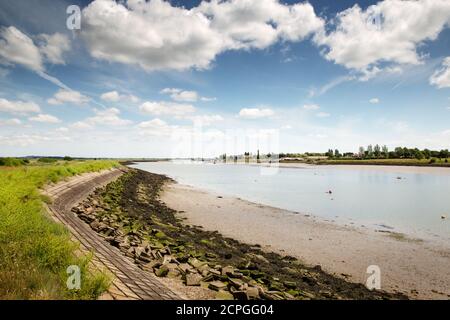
[[73, 169, 407, 300]]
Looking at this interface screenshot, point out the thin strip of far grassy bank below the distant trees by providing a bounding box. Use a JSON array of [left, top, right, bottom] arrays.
[[280, 159, 450, 167]]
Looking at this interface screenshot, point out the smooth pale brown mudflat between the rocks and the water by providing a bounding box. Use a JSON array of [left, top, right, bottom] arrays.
[[161, 182, 450, 299]]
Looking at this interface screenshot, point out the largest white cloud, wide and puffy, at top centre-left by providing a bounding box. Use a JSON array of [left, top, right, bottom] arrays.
[[81, 0, 323, 71]]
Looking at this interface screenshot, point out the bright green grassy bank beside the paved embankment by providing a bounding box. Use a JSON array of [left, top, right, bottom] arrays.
[[0, 161, 118, 299]]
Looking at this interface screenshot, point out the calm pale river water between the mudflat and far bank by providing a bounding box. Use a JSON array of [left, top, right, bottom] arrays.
[[134, 162, 450, 241]]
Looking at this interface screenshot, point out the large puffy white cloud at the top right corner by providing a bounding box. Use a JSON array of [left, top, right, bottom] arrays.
[[315, 0, 450, 76]]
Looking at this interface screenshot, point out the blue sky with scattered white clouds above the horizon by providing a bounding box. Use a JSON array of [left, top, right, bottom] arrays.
[[0, 0, 450, 157]]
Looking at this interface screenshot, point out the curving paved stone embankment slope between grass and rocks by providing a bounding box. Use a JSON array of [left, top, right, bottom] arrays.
[[44, 169, 180, 300]]
